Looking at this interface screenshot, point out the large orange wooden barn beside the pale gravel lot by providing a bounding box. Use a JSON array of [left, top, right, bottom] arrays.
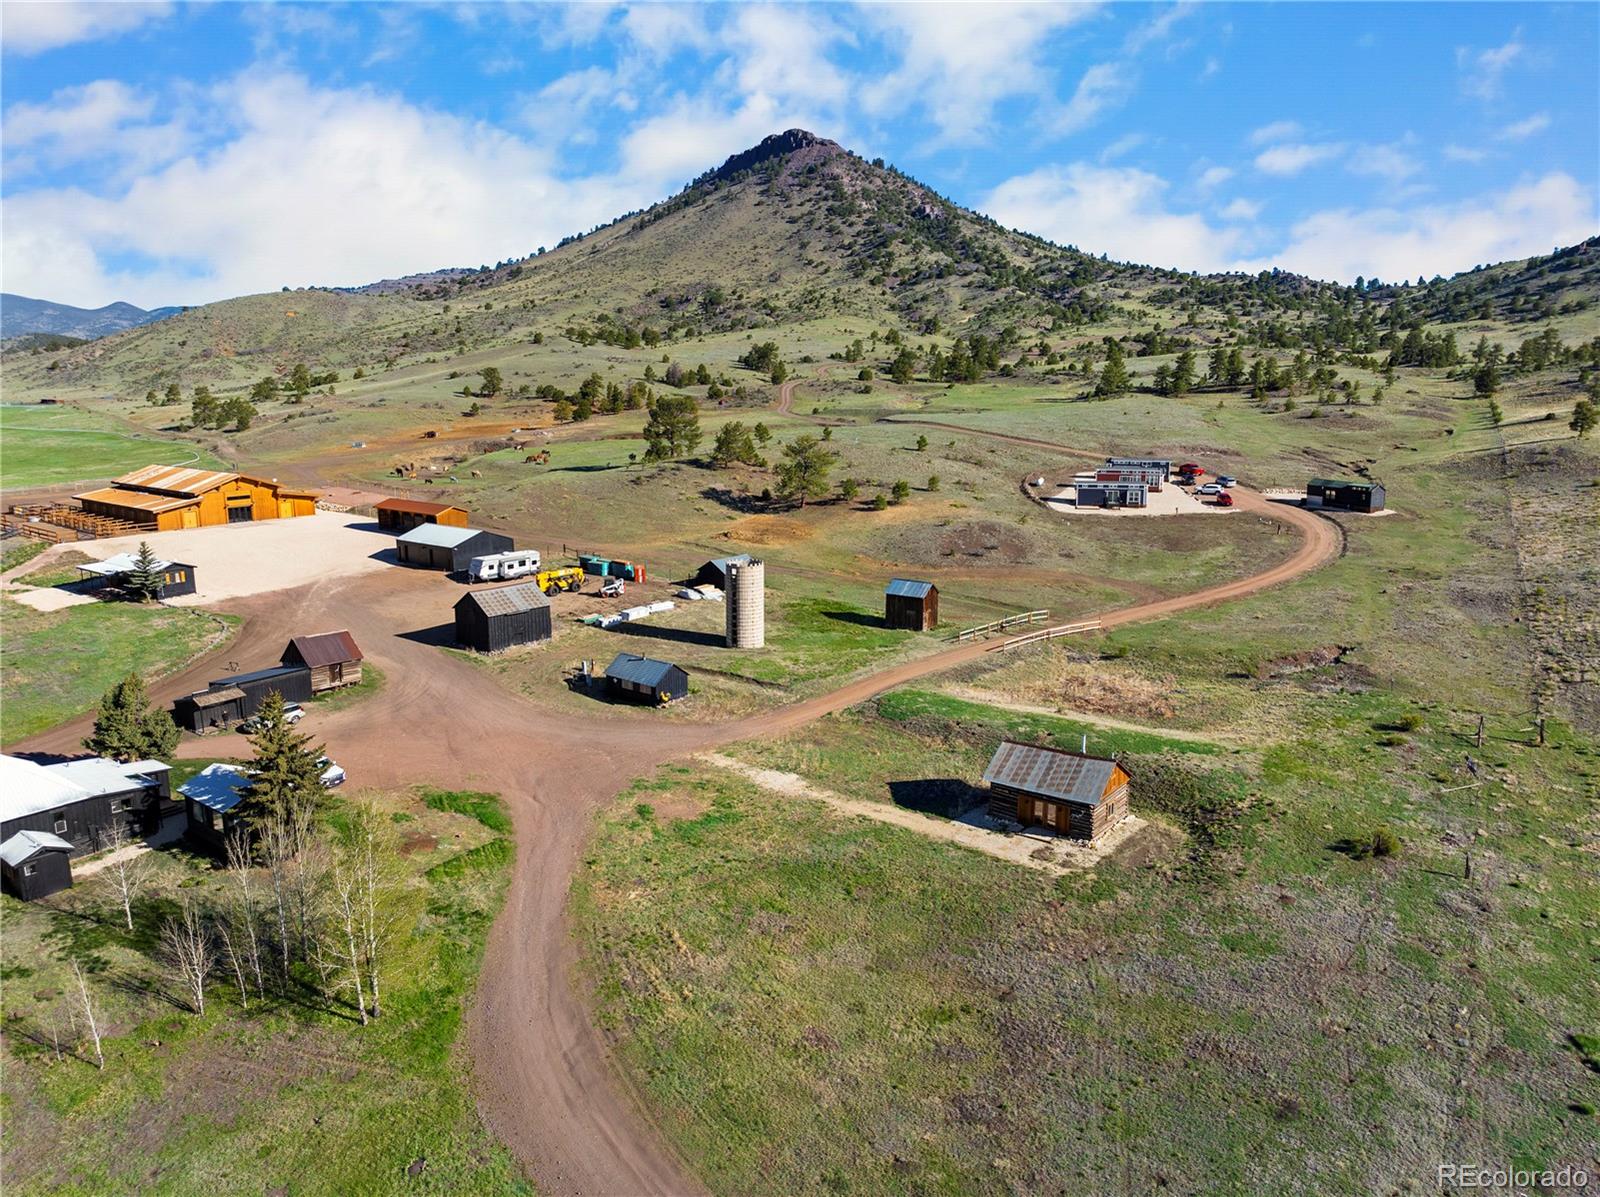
[[74, 466, 317, 531]]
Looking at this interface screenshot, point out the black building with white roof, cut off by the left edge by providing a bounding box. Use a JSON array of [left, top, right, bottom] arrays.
[[0, 757, 171, 855]]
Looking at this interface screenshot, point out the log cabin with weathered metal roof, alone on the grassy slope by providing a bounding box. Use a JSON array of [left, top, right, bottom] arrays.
[[984, 739, 1128, 840]]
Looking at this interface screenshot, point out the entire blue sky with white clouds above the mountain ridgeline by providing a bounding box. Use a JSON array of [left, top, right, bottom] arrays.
[[0, 3, 1600, 306]]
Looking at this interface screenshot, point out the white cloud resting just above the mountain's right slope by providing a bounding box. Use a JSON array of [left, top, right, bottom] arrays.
[[982, 162, 1240, 270]]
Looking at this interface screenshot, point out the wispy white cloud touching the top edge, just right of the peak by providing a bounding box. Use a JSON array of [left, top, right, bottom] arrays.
[[864, 3, 1094, 142]]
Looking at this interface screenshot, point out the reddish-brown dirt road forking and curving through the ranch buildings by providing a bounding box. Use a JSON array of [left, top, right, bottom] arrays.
[[11, 404, 1341, 1195]]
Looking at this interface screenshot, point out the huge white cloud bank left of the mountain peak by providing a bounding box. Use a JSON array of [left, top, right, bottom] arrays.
[[0, 72, 659, 306]]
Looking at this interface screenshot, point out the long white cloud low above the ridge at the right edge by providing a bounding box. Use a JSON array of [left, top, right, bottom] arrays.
[[1240, 171, 1600, 282]]
